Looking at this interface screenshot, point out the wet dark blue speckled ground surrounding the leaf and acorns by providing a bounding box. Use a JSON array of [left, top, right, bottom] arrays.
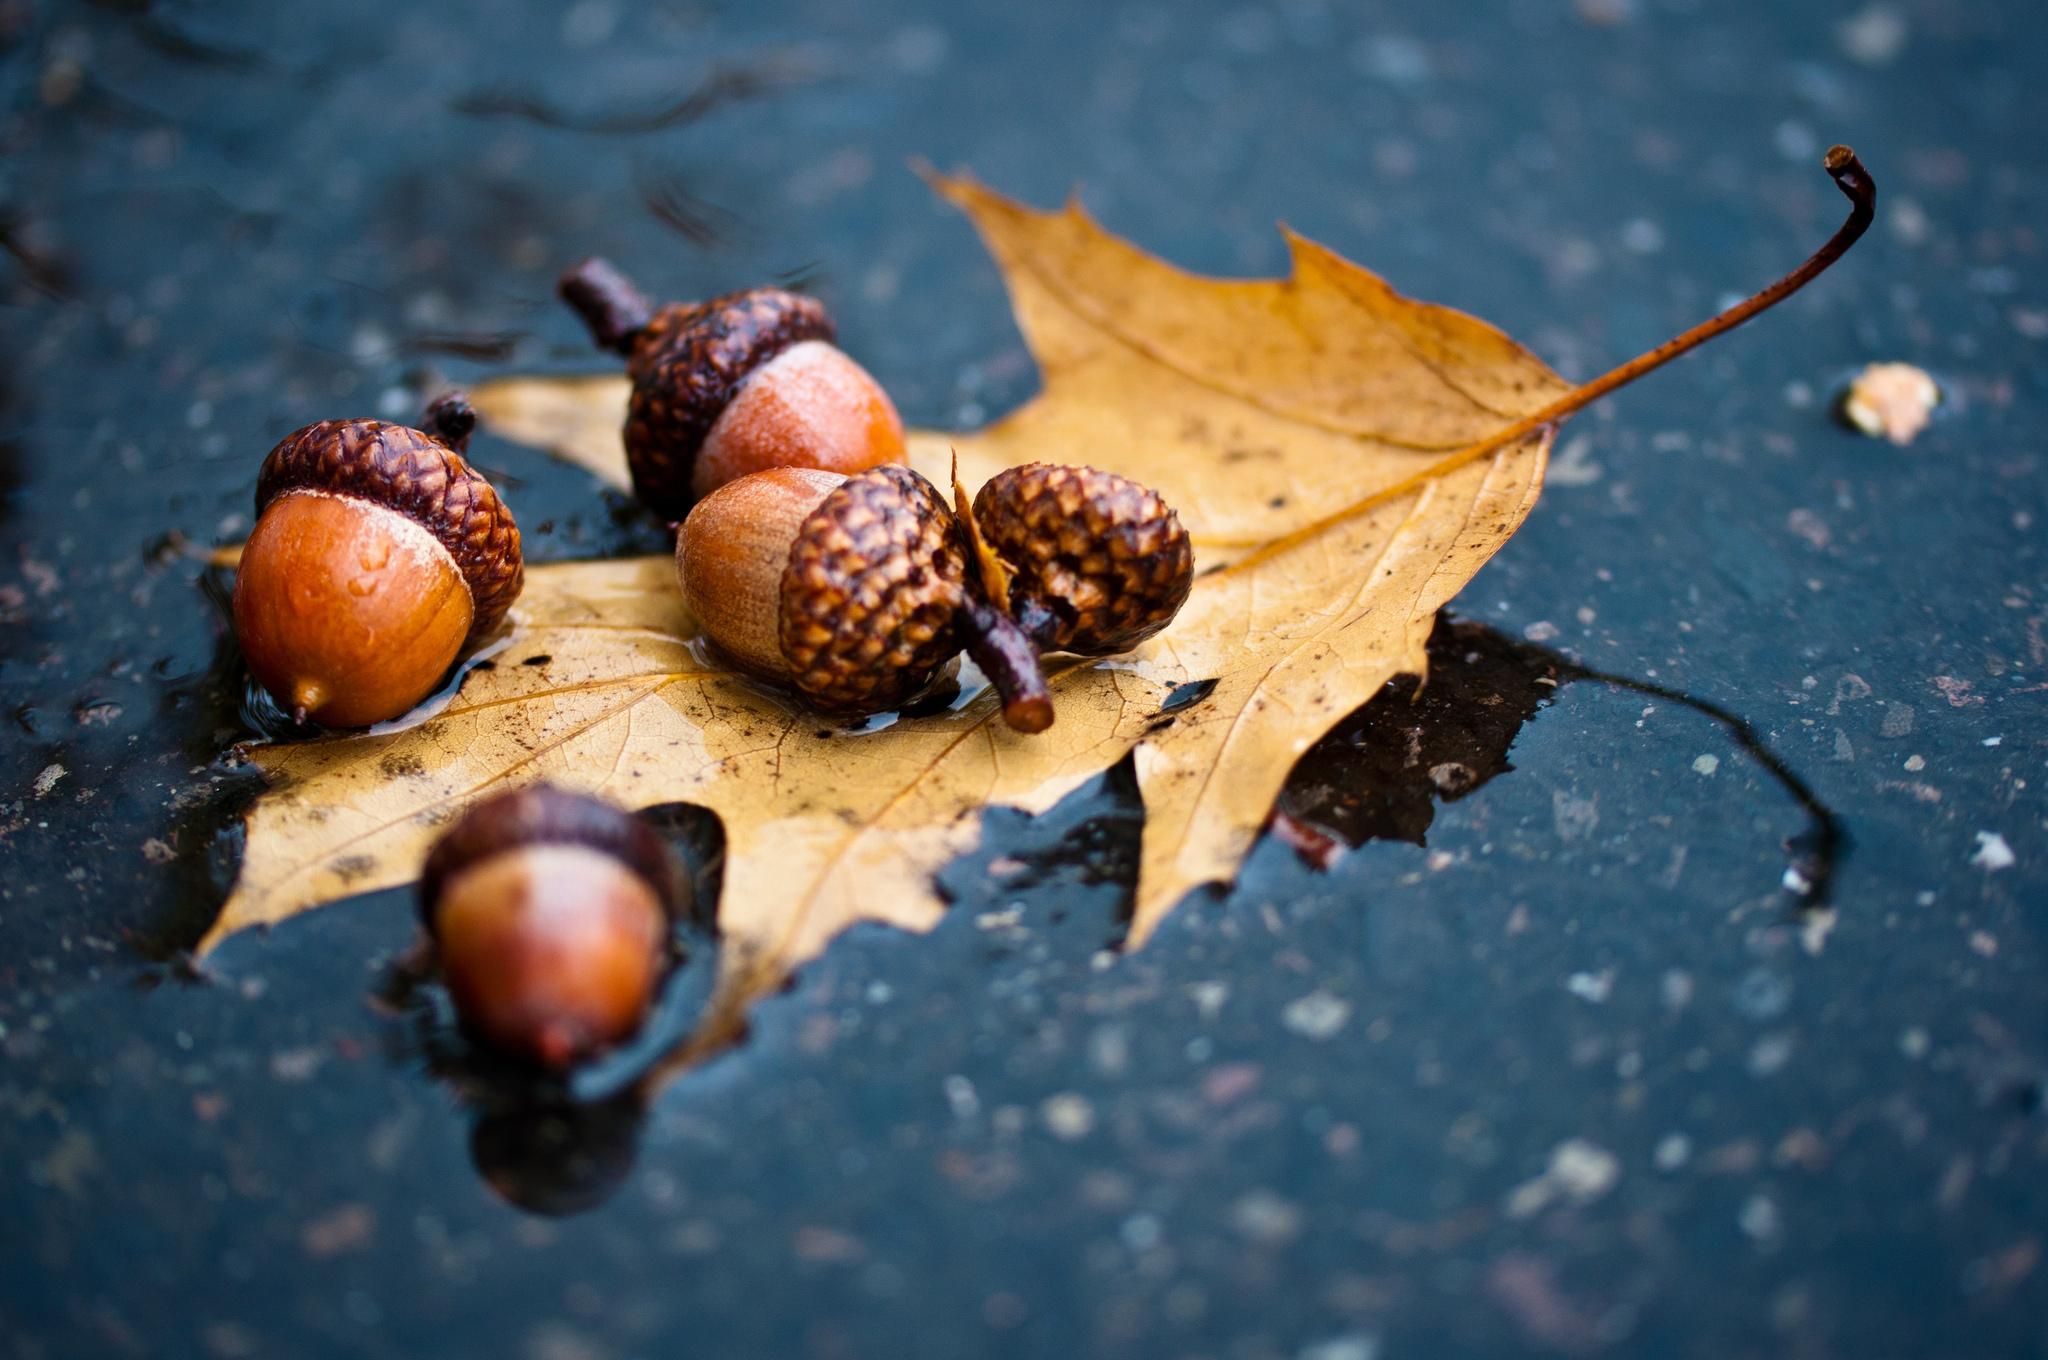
[[0, 0, 2048, 1360]]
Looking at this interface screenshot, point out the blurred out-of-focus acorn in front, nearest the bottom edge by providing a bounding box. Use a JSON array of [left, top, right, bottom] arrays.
[[420, 784, 688, 1069]]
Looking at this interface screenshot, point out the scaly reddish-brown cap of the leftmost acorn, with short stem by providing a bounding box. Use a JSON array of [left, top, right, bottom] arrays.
[[256, 411, 526, 639]]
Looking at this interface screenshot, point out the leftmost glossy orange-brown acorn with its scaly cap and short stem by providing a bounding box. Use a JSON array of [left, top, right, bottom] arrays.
[[233, 393, 524, 727]]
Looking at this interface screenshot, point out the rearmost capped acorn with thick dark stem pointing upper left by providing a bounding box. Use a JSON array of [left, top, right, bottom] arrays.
[[559, 260, 903, 520]]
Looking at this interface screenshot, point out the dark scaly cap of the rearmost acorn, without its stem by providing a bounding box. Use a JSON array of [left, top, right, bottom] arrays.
[[625, 289, 838, 520]]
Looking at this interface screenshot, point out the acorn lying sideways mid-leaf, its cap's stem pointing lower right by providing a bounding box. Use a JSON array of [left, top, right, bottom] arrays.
[[676, 465, 1053, 731]]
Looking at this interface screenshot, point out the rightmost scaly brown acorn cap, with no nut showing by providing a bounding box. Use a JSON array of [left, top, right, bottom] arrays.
[[975, 463, 1194, 655]]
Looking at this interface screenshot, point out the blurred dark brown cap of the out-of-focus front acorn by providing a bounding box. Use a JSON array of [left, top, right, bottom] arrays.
[[420, 784, 686, 934]]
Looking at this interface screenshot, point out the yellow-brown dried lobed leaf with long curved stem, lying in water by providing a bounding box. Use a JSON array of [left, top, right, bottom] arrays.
[[203, 152, 1870, 1065]]
